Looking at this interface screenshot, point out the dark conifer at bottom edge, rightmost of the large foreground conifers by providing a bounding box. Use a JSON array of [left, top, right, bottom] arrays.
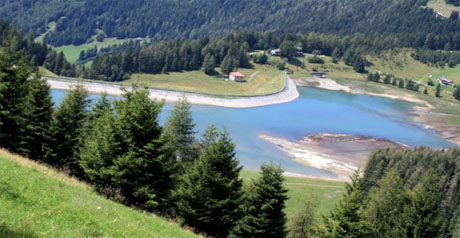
[[234, 164, 288, 238]]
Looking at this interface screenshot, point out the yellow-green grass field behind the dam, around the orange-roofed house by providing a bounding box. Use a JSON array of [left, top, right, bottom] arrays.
[[123, 65, 284, 96]]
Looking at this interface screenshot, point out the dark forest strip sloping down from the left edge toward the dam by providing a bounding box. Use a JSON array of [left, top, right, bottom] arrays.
[[0, 19, 76, 77]]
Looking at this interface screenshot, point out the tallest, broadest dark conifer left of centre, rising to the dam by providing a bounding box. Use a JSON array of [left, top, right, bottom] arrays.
[[110, 86, 176, 212]]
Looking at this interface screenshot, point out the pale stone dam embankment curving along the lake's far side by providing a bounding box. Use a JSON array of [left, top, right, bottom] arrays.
[[44, 75, 300, 108]]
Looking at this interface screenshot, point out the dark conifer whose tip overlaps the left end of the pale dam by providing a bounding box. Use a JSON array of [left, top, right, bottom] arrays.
[[46, 84, 89, 176]]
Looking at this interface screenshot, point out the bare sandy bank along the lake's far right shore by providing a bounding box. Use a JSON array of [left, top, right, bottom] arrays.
[[293, 77, 460, 146]]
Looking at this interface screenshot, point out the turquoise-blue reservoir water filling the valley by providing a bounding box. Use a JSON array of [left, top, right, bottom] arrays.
[[52, 87, 453, 177]]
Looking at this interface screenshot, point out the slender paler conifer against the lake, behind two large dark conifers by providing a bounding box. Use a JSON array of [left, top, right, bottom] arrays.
[[163, 95, 198, 163]]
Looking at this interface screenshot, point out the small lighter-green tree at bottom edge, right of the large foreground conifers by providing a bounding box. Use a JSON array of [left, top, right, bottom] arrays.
[[287, 201, 318, 238]]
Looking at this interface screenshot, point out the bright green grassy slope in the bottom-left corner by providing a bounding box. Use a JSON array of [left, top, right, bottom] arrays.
[[0, 150, 197, 238]]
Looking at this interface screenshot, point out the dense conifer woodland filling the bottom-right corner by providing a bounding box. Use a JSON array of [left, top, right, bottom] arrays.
[[363, 147, 460, 237]]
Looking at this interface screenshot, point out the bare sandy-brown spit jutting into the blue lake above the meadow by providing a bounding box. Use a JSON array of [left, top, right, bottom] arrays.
[[259, 133, 409, 181]]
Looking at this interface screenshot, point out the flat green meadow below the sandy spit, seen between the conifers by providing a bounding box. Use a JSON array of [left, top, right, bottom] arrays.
[[241, 170, 345, 219]]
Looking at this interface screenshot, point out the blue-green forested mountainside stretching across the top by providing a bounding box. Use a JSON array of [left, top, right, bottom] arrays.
[[0, 0, 460, 49]]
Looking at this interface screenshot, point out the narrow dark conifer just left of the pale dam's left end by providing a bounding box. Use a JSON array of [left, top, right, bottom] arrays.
[[20, 76, 54, 161]]
